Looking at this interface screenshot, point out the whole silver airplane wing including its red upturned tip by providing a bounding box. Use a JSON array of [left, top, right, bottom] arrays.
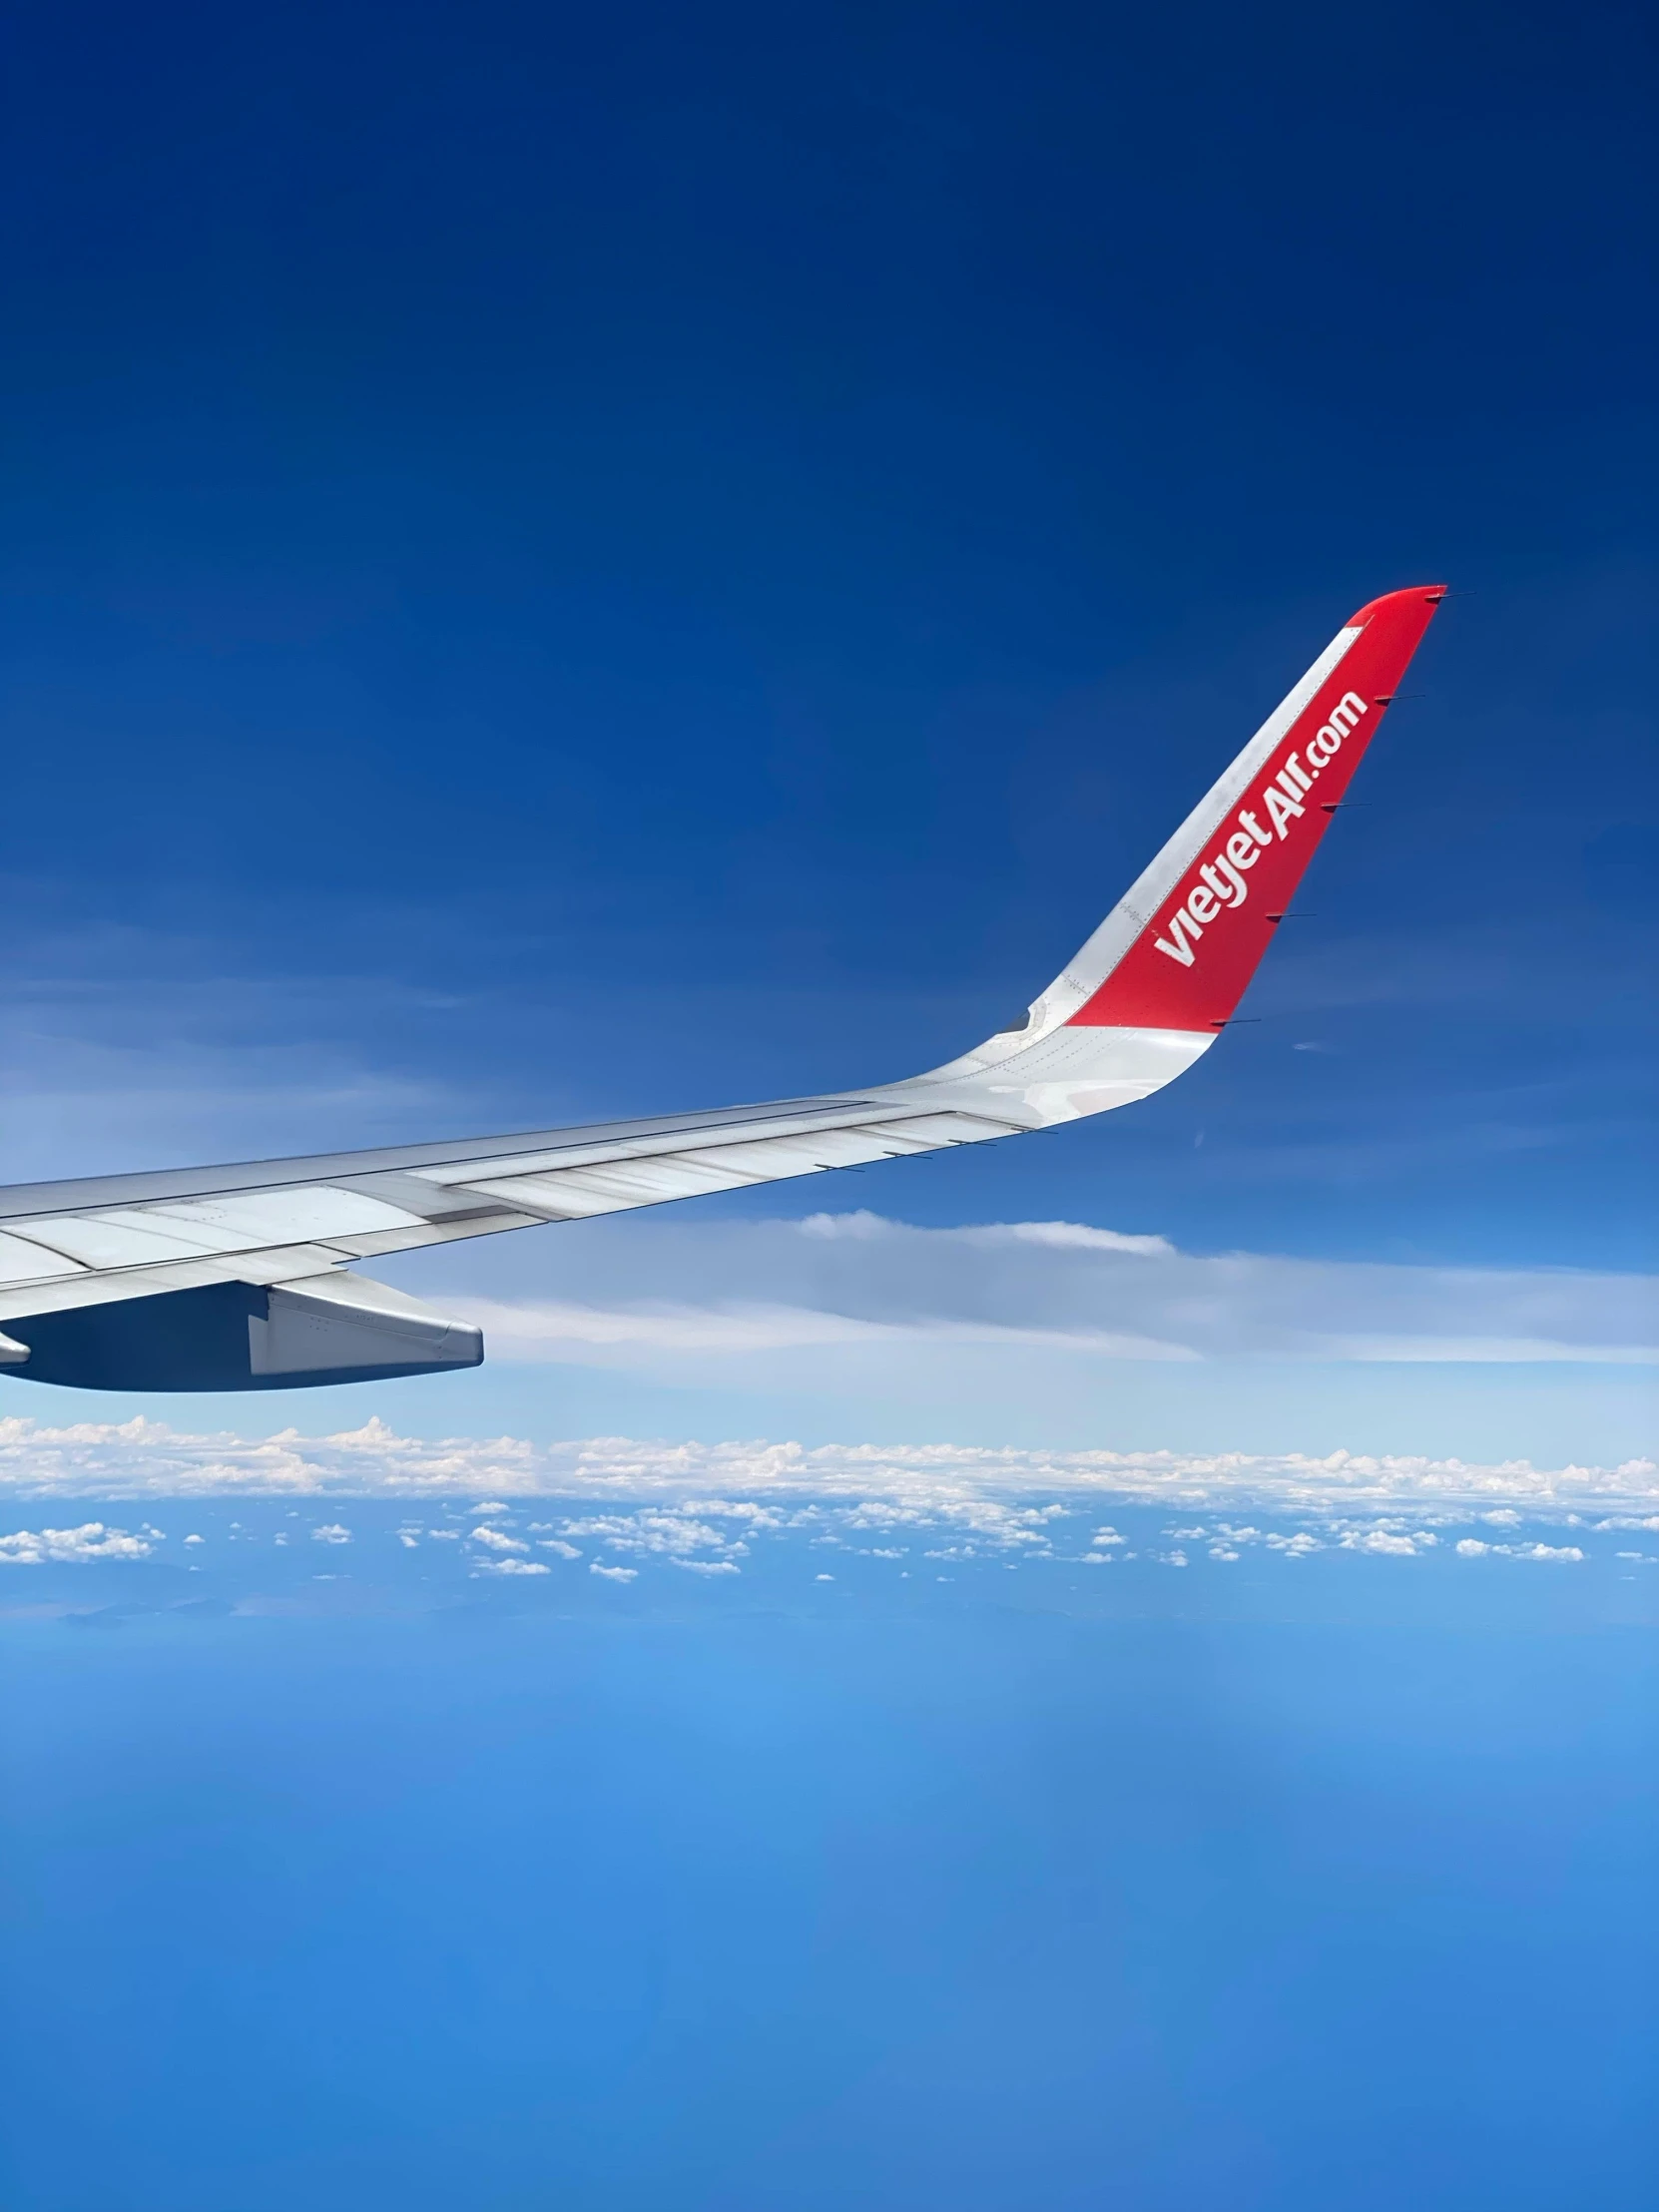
[[0, 584, 1444, 1389]]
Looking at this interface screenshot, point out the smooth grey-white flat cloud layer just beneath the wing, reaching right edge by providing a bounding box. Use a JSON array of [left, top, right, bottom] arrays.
[[406, 1212, 1659, 1381]]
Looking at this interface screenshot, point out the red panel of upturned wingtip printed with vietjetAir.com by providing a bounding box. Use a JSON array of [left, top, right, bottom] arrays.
[[1071, 584, 1446, 1031]]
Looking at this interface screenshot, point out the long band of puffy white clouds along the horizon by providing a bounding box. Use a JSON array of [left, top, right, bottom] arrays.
[[0, 1417, 1659, 1555]]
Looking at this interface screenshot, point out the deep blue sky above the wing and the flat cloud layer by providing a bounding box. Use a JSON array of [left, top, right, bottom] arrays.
[[0, 7, 1659, 1266]]
